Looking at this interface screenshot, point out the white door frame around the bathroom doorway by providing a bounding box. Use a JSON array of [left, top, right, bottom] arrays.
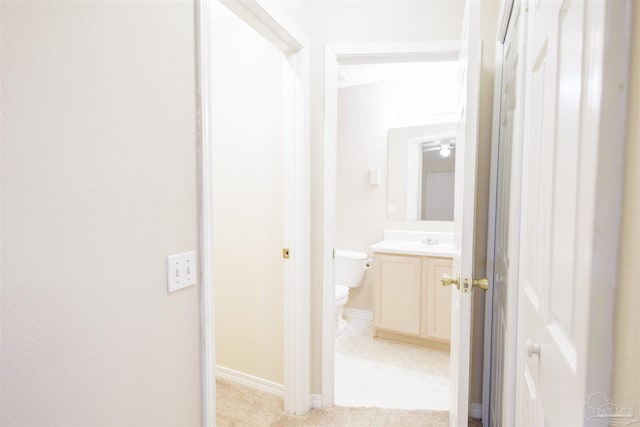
[[322, 40, 460, 408]]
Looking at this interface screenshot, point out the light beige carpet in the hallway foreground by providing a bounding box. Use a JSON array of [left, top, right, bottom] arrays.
[[216, 380, 449, 427]]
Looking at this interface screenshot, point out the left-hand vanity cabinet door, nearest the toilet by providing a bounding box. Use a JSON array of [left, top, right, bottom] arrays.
[[375, 255, 422, 335]]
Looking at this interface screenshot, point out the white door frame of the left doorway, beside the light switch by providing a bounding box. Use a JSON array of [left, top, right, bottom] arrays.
[[196, 0, 311, 426]]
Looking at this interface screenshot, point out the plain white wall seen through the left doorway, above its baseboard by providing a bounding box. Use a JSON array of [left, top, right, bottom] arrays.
[[212, 2, 284, 384]]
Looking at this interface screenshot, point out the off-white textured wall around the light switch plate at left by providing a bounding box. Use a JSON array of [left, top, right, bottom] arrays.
[[0, 1, 201, 426]]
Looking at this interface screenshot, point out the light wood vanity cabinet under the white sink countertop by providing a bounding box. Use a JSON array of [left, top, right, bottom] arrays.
[[374, 253, 452, 349]]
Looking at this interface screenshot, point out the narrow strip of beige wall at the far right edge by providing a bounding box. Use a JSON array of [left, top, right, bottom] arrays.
[[612, 0, 640, 418]]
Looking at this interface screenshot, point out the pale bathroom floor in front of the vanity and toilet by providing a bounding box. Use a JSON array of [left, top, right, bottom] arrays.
[[335, 317, 449, 410]]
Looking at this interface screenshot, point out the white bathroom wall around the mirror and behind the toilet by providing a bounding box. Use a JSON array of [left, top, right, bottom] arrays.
[[336, 77, 457, 311]]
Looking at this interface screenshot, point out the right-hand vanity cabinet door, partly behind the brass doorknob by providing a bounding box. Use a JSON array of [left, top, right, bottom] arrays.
[[423, 258, 453, 341]]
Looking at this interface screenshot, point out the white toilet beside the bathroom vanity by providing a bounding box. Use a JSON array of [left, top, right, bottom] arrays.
[[333, 249, 371, 336]]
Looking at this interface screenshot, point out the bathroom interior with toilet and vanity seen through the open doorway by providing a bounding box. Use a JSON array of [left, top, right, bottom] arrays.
[[334, 61, 458, 410]]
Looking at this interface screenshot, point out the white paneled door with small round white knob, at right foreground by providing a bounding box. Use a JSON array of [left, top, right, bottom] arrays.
[[516, 0, 626, 426]]
